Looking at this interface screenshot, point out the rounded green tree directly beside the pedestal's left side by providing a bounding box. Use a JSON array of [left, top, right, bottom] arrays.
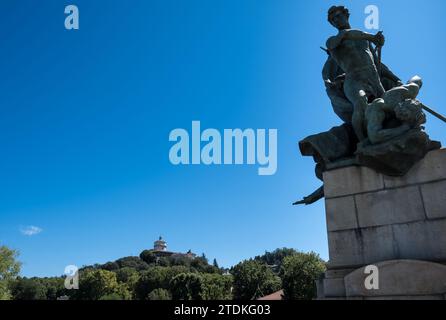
[[280, 252, 325, 300]]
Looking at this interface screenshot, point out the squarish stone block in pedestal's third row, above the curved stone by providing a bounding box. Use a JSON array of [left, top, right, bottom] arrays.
[[361, 226, 397, 264]]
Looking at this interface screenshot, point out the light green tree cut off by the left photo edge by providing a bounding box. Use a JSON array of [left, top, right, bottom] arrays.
[[0, 246, 21, 300]]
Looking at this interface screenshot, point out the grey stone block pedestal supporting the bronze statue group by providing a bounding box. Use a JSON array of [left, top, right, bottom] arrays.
[[318, 149, 446, 299]]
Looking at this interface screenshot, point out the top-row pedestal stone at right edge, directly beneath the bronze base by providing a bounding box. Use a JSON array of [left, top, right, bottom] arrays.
[[384, 149, 446, 188]]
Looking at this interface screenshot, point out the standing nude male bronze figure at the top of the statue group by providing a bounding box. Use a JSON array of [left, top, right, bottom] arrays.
[[326, 6, 400, 141]]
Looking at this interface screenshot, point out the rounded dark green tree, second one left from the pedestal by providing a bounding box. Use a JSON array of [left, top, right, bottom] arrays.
[[231, 259, 281, 300]]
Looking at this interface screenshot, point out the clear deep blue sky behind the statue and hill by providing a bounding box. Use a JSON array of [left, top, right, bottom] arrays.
[[0, 0, 446, 276]]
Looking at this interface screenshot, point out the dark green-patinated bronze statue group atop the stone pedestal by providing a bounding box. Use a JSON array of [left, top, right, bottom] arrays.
[[294, 6, 445, 205]]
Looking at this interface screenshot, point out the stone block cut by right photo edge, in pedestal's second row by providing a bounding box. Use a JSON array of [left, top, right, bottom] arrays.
[[421, 180, 446, 219]]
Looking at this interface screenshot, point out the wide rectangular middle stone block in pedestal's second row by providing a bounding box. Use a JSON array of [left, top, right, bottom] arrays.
[[355, 186, 426, 228]]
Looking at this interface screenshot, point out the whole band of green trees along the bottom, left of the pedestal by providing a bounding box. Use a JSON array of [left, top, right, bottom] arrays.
[[0, 247, 325, 300]]
